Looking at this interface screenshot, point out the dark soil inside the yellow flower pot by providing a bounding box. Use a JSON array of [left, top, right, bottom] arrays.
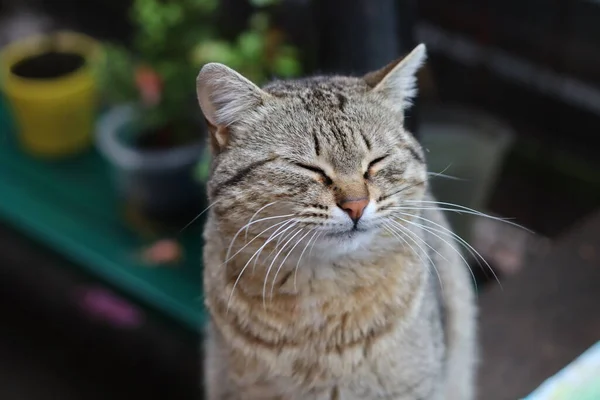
[[11, 51, 85, 79]]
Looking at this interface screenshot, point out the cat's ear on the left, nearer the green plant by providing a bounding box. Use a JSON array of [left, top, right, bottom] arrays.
[[196, 63, 268, 151]]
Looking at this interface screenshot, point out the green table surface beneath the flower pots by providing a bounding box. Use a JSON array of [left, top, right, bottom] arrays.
[[0, 99, 204, 330]]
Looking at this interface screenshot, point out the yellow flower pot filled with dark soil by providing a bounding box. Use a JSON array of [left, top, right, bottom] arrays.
[[0, 32, 99, 158]]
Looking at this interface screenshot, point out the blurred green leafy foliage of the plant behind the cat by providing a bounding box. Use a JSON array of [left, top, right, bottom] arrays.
[[98, 0, 300, 143]]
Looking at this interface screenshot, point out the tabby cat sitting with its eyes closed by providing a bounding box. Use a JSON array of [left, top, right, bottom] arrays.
[[197, 44, 477, 400]]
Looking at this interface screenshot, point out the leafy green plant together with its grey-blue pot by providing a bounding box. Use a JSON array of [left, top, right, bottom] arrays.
[[97, 0, 299, 231]]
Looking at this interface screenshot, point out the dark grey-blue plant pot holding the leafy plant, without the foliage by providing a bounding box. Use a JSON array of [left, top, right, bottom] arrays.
[[97, 106, 206, 233]]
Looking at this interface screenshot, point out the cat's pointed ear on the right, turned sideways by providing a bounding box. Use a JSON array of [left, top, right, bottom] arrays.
[[363, 44, 427, 111]]
